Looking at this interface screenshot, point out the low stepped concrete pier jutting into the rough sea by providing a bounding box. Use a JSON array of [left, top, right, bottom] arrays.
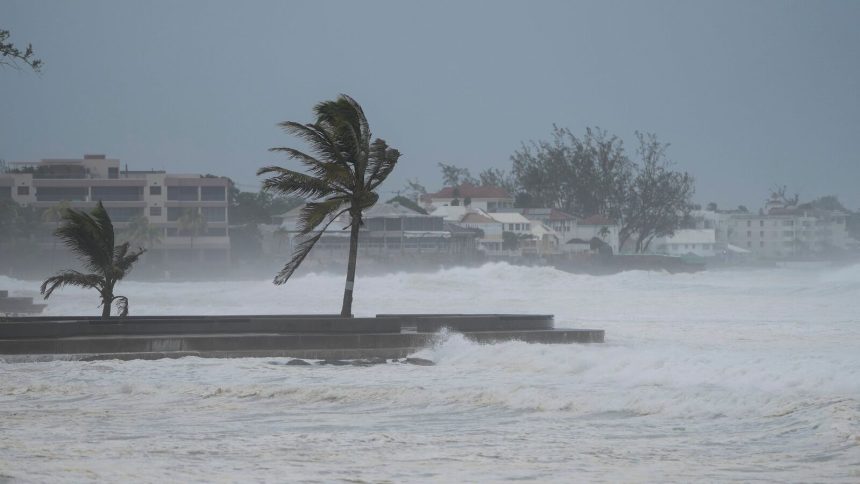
[[0, 314, 604, 361]]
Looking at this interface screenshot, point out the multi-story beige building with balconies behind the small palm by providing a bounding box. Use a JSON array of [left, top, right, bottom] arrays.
[[0, 155, 230, 264]]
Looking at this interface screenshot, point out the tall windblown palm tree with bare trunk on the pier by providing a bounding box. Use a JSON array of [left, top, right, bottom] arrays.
[[257, 94, 400, 316]]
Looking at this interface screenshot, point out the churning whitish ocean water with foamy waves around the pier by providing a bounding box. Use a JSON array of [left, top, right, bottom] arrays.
[[0, 264, 860, 483]]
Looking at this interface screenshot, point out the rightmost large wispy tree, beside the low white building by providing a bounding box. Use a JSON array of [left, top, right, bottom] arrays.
[[619, 132, 694, 252]]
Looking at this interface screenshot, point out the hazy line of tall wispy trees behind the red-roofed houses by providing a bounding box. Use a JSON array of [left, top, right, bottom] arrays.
[[420, 126, 695, 252]]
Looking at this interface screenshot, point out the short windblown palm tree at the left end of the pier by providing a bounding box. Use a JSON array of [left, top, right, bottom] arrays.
[[41, 202, 146, 318]]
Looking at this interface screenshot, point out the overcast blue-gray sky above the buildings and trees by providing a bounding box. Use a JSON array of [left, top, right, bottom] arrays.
[[0, 0, 860, 209]]
